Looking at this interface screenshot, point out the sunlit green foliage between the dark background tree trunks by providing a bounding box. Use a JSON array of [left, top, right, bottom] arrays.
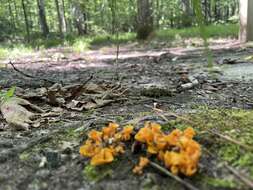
[[0, 0, 238, 41]]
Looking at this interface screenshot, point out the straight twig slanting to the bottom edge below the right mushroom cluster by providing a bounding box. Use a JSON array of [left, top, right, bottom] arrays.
[[149, 161, 199, 190]]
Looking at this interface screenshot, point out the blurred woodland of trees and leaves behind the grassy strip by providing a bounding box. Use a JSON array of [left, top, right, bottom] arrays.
[[0, 0, 239, 42]]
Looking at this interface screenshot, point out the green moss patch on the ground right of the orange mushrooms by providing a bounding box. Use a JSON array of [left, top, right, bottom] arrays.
[[184, 108, 253, 180]]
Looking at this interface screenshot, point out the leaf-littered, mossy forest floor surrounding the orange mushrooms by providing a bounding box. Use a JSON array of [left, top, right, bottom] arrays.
[[0, 40, 253, 190]]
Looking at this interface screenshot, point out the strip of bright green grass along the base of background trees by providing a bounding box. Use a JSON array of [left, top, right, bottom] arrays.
[[0, 24, 239, 56]]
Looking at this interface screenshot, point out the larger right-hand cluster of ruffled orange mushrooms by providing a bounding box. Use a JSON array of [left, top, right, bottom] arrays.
[[135, 123, 201, 176]]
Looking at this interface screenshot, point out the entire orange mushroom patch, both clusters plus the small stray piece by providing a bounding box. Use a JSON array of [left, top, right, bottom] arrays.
[[80, 122, 201, 176]]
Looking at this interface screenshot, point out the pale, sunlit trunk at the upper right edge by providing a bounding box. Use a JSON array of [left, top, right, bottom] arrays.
[[239, 0, 253, 42]]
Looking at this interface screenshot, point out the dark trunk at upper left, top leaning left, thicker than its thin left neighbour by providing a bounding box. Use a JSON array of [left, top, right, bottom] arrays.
[[37, 0, 49, 37]]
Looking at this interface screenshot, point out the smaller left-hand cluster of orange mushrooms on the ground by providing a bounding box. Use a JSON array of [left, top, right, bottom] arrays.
[[79, 123, 134, 166]]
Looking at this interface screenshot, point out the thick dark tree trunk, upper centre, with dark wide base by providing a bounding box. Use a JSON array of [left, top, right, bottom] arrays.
[[137, 0, 153, 40]]
